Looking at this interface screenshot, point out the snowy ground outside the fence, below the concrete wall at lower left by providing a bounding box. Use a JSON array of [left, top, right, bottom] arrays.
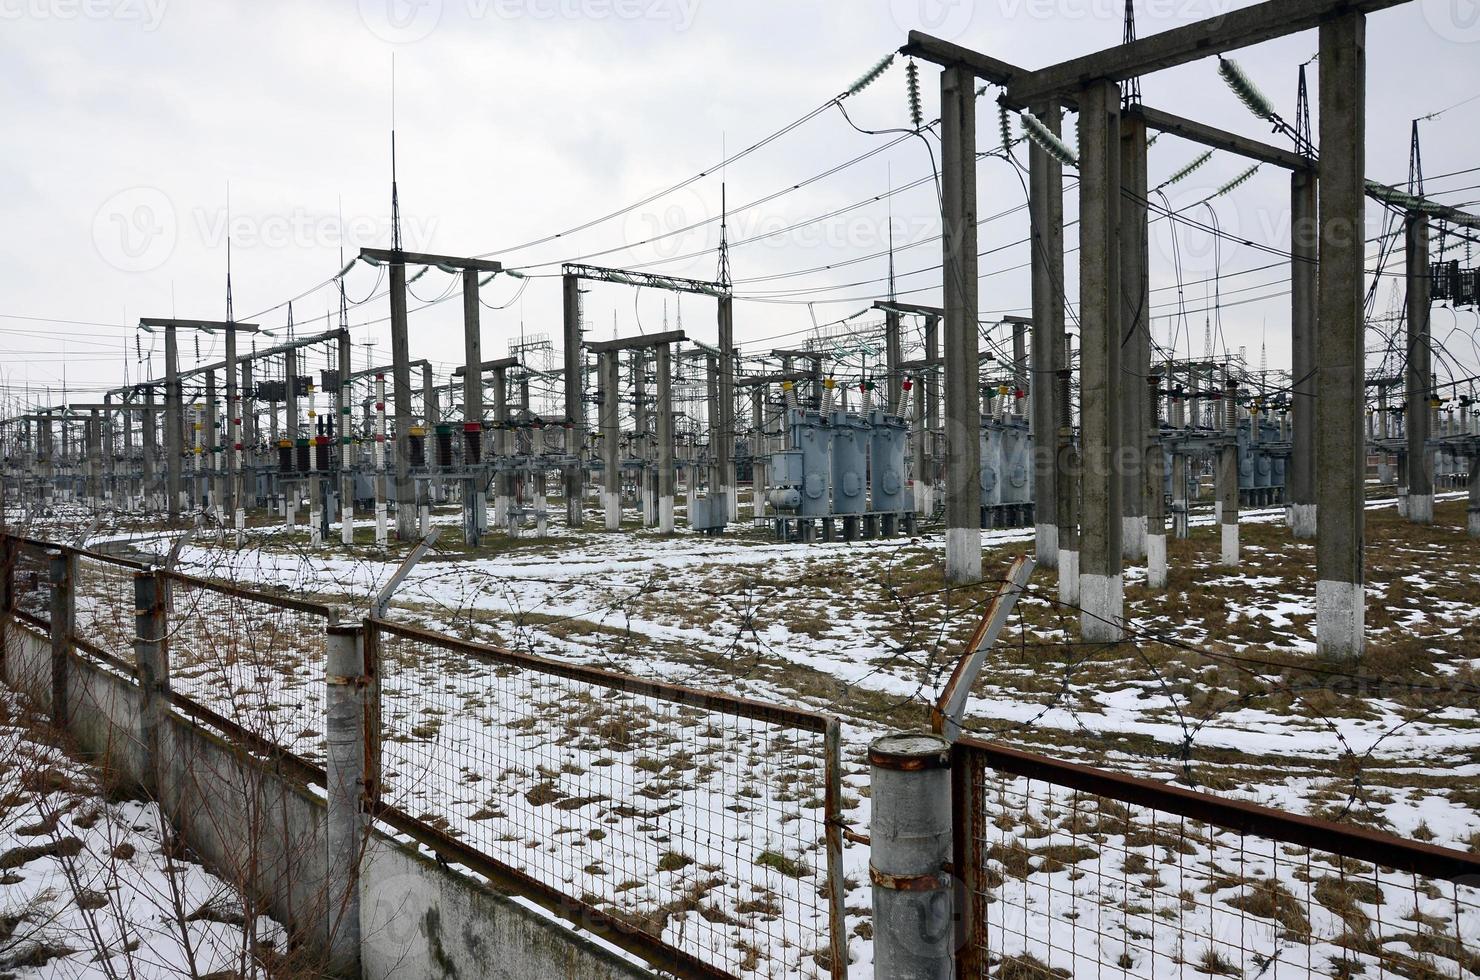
[[0, 688, 284, 980]]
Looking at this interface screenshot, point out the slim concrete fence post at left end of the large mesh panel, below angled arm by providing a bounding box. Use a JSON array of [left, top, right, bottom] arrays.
[[324, 623, 369, 977]]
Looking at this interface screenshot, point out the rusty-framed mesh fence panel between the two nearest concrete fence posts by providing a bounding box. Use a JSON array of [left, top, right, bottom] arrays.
[[367, 619, 847, 977]]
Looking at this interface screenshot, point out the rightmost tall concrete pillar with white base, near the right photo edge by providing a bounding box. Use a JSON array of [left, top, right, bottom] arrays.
[[1403, 212, 1434, 524]]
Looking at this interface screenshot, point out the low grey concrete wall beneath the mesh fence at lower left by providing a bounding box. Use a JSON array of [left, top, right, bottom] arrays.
[[3, 623, 653, 980]]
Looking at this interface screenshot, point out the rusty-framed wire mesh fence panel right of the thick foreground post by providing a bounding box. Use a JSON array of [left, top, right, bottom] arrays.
[[952, 739, 1480, 980]]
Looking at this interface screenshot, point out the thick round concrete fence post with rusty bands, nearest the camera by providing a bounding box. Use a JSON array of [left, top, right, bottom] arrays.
[[869, 731, 956, 980]]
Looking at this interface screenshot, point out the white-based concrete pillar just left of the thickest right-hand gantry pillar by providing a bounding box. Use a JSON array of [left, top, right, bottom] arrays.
[[1286, 170, 1320, 537]]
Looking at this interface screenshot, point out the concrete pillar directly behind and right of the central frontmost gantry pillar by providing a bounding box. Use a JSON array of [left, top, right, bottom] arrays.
[[1119, 115, 1151, 561]]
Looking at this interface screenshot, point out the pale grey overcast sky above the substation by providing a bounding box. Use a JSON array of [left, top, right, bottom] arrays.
[[0, 0, 1480, 401]]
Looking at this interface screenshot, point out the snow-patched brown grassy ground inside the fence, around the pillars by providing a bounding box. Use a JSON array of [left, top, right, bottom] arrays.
[[5, 494, 1480, 976]]
